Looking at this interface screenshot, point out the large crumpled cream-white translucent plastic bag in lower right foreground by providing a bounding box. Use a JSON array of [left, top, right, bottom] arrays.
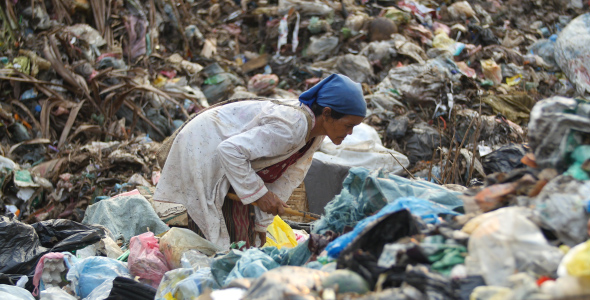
[[463, 207, 563, 286]]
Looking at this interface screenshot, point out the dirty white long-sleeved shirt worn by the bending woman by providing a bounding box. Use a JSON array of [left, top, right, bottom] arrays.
[[154, 100, 324, 248]]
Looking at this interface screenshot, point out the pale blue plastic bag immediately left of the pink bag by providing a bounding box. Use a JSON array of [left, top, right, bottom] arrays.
[[66, 256, 131, 298]]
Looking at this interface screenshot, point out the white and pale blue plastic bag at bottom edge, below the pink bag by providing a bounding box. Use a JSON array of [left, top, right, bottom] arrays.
[[155, 268, 220, 300]]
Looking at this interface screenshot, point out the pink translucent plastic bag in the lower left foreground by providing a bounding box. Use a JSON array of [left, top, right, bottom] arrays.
[[128, 232, 170, 288]]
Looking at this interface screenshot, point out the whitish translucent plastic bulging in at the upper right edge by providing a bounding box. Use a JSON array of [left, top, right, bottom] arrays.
[[555, 13, 590, 94]]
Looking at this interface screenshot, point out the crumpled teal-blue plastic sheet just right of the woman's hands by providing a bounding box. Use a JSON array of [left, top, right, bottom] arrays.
[[312, 168, 463, 234]]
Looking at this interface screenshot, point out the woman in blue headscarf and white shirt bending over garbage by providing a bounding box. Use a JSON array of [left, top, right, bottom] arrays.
[[154, 74, 366, 249]]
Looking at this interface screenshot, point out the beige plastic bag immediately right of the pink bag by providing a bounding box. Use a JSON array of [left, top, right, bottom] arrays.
[[160, 227, 222, 269]]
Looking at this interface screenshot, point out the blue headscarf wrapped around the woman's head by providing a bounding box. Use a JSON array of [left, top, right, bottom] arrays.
[[299, 74, 367, 117]]
